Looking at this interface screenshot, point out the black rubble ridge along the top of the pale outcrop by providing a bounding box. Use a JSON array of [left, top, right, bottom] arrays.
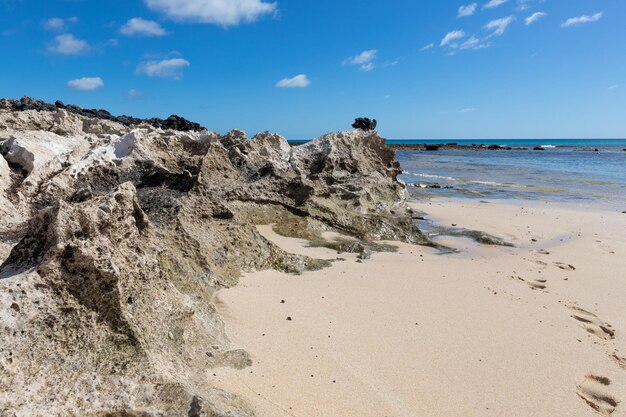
[[0, 97, 206, 132]]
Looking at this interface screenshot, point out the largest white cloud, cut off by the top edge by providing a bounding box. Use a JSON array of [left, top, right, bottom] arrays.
[[144, 0, 277, 26]]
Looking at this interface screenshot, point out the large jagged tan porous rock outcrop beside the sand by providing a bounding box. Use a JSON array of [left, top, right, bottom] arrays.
[[0, 101, 425, 417]]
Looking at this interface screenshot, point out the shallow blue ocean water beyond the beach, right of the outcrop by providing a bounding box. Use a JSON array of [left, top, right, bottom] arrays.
[[388, 139, 626, 207]]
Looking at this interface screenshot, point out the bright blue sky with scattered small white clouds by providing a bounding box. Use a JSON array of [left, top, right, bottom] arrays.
[[0, 0, 626, 139]]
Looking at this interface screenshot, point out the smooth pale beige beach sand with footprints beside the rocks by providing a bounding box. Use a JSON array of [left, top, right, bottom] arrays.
[[212, 199, 626, 417]]
